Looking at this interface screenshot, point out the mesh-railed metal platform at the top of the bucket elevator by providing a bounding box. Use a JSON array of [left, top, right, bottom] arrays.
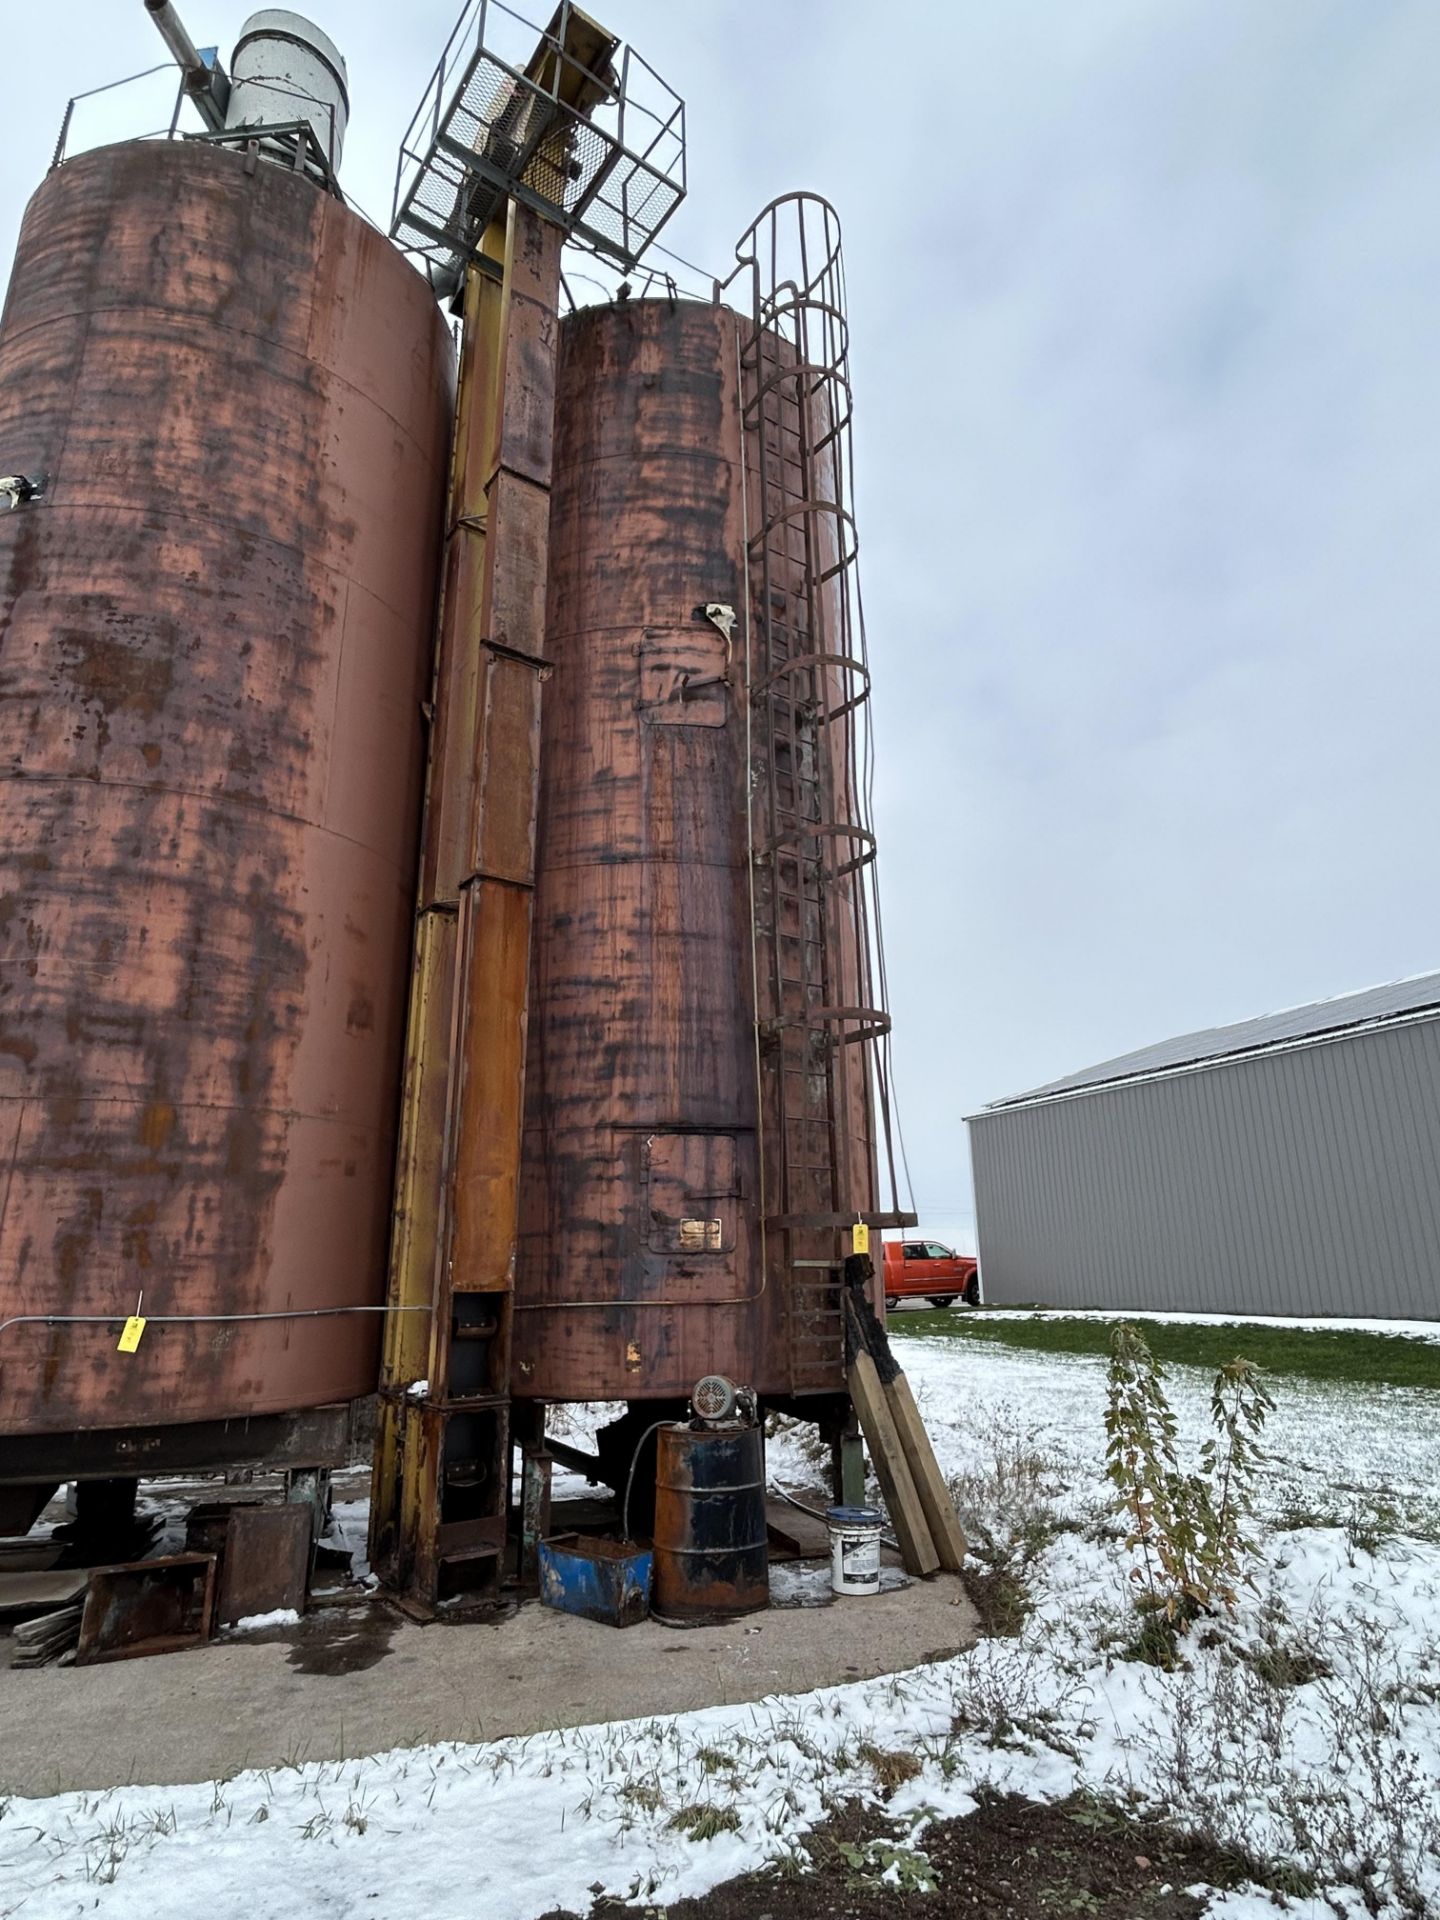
[[390, 0, 685, 280]]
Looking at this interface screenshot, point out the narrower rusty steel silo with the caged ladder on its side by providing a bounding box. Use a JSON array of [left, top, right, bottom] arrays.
[[515, 202, 899, 1404]]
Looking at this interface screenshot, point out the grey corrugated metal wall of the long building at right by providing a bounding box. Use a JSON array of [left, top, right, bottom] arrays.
[[970, 1021, 1440, 1319]]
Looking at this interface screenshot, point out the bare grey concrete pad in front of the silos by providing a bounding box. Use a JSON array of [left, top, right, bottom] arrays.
[[0, 1563, 977, 1795]]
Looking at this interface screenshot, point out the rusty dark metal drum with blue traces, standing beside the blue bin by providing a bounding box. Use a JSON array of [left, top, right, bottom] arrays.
[[651, 1425, 770, 1626]]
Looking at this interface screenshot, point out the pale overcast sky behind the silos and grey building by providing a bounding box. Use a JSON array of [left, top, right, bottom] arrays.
[[0, 0, 1440, 1244]]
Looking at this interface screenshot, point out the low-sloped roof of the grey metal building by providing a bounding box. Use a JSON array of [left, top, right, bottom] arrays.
[[975, 973, 1440, 1119]]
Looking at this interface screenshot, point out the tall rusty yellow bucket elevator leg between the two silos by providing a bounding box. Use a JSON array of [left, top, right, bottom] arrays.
[[371, 149, 591, 1613]]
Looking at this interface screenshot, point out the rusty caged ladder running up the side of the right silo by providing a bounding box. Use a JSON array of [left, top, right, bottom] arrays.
[[716, 192, 914, 1390]]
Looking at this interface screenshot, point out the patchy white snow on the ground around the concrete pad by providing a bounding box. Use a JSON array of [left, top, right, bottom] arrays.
[[0, 1338, 1440, 1920]]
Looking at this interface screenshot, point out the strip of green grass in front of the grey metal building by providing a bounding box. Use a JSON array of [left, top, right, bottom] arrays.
[[889, 1308, 1440, 1392]]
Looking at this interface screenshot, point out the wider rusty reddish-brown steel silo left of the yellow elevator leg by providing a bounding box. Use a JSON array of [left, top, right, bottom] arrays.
[[0, 142, 451, 1450]]
